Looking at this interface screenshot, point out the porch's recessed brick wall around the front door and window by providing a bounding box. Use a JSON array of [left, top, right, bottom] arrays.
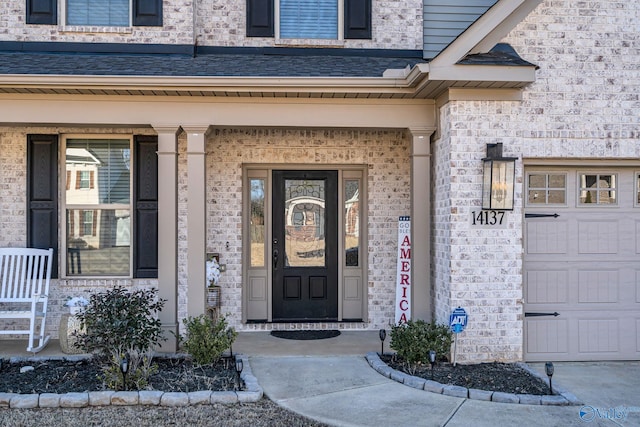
[[0, 127, 410, 337]]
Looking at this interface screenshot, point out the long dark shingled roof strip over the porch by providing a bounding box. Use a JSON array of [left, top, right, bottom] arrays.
[[0, 45, 425, 77]]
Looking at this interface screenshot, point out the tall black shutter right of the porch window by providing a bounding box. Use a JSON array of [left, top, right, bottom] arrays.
[[133, 135, 158, 278]]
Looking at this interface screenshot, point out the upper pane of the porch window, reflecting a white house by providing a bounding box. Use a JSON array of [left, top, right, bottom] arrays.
[[66, 139, 131, 205]]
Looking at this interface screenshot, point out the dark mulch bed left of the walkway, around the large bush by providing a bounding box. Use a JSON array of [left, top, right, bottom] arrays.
[[0, 358, 238, 394]]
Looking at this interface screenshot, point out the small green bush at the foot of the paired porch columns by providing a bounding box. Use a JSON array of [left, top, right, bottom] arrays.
[[181, 314, 238, 365]]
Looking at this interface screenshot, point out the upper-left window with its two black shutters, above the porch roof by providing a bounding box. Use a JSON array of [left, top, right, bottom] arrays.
[[26, 0, 162, 27]]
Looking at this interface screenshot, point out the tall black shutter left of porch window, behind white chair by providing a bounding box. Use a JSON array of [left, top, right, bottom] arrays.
[[27, 135, 58, 277]]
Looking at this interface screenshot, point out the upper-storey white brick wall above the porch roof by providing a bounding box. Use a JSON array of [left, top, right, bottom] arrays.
[[0, 0, 422, 49]]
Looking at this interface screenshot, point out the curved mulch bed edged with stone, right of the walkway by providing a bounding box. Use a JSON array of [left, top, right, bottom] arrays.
[[381, 355, 549, 396]]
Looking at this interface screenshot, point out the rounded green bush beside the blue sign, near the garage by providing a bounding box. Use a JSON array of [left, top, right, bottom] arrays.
[[391, 320, 452, 365]]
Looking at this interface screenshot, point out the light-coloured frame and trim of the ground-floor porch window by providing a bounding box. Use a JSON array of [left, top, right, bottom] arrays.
[[58, 134, 135, 280]]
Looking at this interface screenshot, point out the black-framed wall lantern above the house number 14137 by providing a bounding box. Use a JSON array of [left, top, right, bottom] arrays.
[[482, 142, 517, 211]]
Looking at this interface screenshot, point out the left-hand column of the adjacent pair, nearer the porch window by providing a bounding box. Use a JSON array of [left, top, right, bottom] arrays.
[[153, 125, 180, 352]]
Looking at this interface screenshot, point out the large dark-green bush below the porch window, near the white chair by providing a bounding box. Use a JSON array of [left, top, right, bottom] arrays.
[[74, 287, 166, 390]]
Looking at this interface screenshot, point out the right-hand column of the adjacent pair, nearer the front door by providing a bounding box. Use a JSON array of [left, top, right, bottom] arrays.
[[182, 125, 209, 316]]
